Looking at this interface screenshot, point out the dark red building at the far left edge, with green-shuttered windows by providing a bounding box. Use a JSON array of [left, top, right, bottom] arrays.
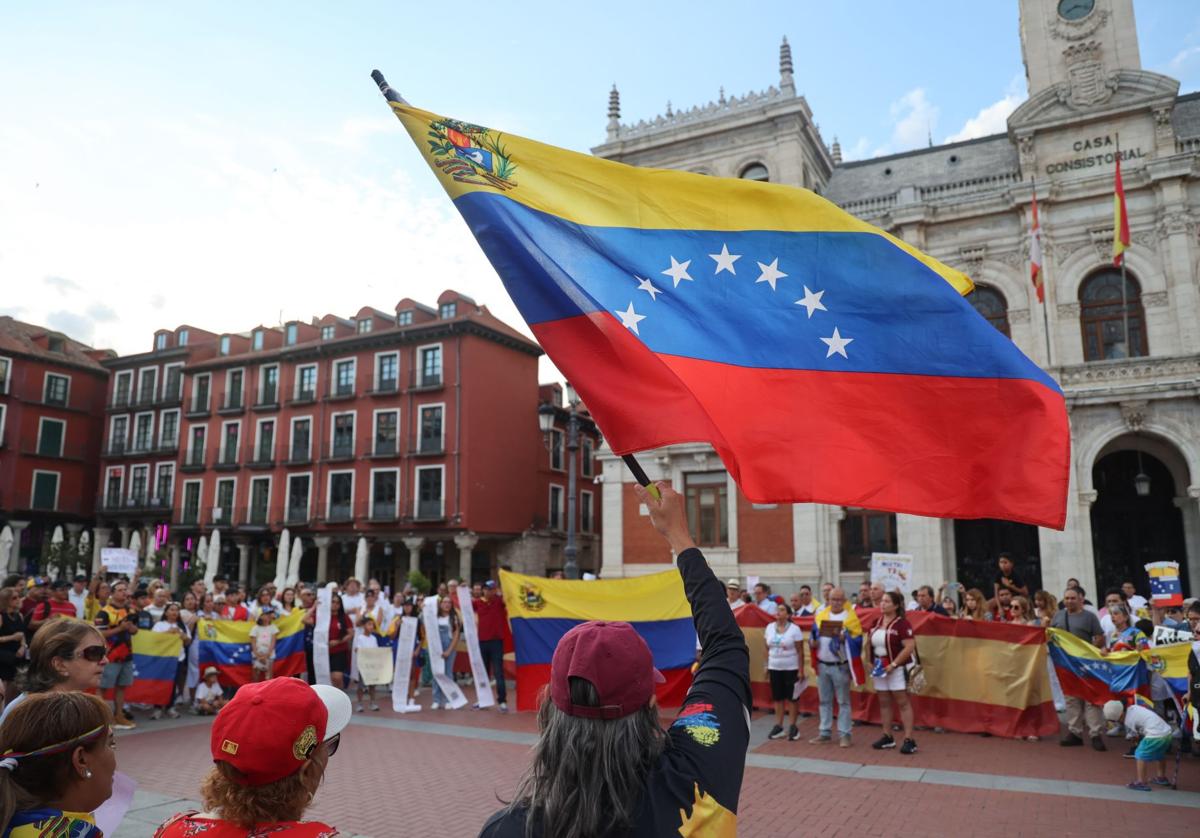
[[0, 317, 114, 570]]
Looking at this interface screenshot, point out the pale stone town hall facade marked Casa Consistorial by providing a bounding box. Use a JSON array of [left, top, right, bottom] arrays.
[[594, 0, 1200, 593]]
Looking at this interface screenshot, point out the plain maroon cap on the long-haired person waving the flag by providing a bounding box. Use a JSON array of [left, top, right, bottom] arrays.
[[550, 619, 666, 719]]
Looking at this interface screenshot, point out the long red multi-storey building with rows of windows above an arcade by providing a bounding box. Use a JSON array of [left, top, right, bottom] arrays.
[[93, 291, 600, 583]]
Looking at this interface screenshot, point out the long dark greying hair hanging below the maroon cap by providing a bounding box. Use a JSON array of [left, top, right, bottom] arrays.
[[509, 678, 667, 838]]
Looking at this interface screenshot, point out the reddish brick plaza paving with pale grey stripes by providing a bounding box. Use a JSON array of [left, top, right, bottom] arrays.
[[108, 690, 1200, 838]]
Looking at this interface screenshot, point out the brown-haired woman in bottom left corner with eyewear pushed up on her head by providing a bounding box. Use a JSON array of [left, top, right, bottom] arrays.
[[0, 686, 116, 838]]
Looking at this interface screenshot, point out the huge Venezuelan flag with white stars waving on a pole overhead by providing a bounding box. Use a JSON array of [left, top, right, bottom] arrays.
[[377, 84, 1068, 528]]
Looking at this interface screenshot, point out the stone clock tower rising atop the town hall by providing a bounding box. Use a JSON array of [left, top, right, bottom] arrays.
[[1020, 0, 1141, 102]]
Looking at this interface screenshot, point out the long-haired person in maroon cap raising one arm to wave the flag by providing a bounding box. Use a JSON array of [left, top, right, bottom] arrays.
[[480, 483, 750, 838]]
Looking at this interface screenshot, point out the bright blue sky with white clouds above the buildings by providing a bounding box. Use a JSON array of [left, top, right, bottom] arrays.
[[0, 0, 1200, 372]]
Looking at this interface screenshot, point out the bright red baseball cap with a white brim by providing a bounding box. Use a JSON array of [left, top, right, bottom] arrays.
[[211, 678, 350, 785]]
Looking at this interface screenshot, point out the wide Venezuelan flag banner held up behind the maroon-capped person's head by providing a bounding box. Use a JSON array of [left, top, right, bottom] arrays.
[[500, 570, 696, 710]]
